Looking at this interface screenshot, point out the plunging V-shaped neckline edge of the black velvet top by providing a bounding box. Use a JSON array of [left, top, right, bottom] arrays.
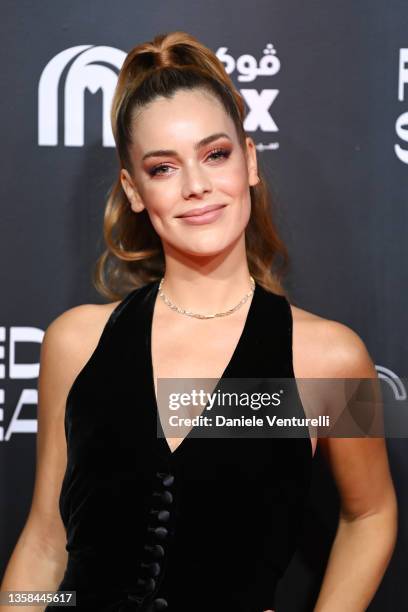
[[146, 281, 260, 457]]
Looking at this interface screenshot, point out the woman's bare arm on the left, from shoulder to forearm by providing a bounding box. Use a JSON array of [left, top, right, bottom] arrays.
[[0, 304, 115, 612]]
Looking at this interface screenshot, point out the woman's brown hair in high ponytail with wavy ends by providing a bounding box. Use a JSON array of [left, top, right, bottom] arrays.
[[93, 31, 289, 300]]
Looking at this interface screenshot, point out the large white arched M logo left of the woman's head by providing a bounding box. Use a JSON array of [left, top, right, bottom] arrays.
[[38, 45, 126, 147]]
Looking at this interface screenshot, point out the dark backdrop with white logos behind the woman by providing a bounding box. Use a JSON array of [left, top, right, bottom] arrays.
[[0, 0, 408, 612]]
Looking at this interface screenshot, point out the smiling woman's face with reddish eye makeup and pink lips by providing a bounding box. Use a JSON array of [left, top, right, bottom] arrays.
[[121, 90, 259, 256]]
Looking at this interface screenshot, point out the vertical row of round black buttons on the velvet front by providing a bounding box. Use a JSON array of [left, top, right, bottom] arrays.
[[128, 472, 174, 612]]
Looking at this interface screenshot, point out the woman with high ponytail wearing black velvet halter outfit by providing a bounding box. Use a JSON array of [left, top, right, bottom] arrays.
[[2, 32, 397, 612]]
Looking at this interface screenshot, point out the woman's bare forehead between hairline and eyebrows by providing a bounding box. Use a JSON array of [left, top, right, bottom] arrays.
[[132, 90, 234, 150]]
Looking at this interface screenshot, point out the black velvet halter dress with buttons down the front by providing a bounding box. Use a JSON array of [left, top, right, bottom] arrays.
[[46, 281, 312, 612]]
